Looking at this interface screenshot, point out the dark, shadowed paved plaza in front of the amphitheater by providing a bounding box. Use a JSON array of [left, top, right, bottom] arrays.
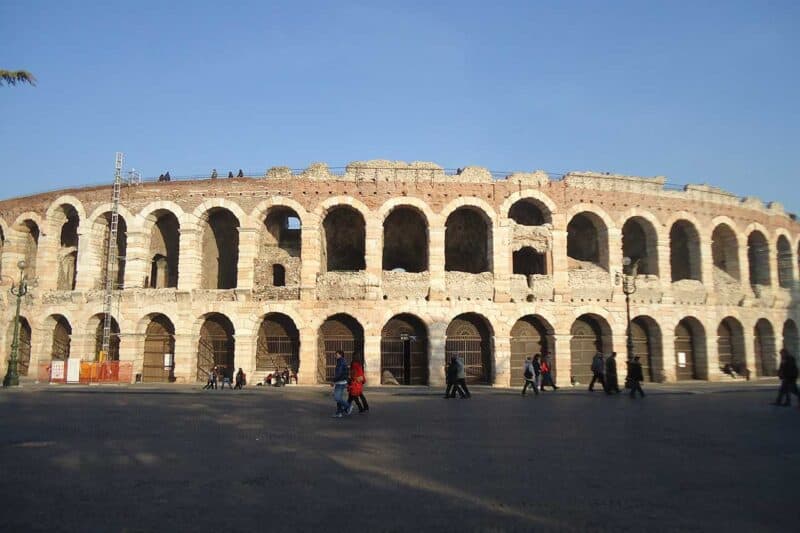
[[0, 383, 800, 532]]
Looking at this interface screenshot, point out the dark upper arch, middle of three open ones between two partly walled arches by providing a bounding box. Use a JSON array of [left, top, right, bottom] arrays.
[[383, 206, 428, 272]]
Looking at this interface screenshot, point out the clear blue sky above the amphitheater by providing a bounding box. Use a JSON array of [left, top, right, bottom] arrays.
[[0, 0, 800, 211]]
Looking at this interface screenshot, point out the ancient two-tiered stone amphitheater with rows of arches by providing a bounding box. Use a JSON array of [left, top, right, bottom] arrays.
[[0, 161, 800, 386]]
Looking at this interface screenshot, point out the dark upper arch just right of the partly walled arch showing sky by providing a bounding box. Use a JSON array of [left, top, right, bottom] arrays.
[[322, 206, 366, 272]]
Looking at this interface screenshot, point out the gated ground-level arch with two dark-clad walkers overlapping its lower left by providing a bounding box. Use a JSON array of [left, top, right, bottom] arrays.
[[444, 313, 492, 384]]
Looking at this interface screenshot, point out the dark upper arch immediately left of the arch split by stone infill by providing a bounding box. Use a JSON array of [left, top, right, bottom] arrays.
[[444, 207, 492, 274]]
